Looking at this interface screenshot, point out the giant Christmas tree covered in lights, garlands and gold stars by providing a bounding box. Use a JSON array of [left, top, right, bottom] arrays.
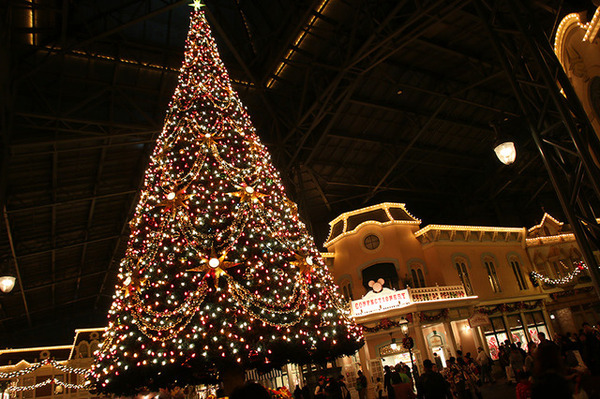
[[92, 1, 362, 394]]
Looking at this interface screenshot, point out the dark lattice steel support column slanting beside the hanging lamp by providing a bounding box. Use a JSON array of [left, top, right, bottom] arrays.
[[475, 0, 600, 296]]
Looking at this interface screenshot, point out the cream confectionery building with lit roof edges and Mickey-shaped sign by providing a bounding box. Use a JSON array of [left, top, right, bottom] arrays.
[[324, 203, 600, 390]]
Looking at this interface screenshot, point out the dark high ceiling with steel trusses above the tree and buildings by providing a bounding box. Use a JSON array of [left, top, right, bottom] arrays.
[[0, 0, 593, 346]]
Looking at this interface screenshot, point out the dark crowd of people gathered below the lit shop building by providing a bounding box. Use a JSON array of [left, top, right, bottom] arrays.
[[232, 323, 600, 399]]
